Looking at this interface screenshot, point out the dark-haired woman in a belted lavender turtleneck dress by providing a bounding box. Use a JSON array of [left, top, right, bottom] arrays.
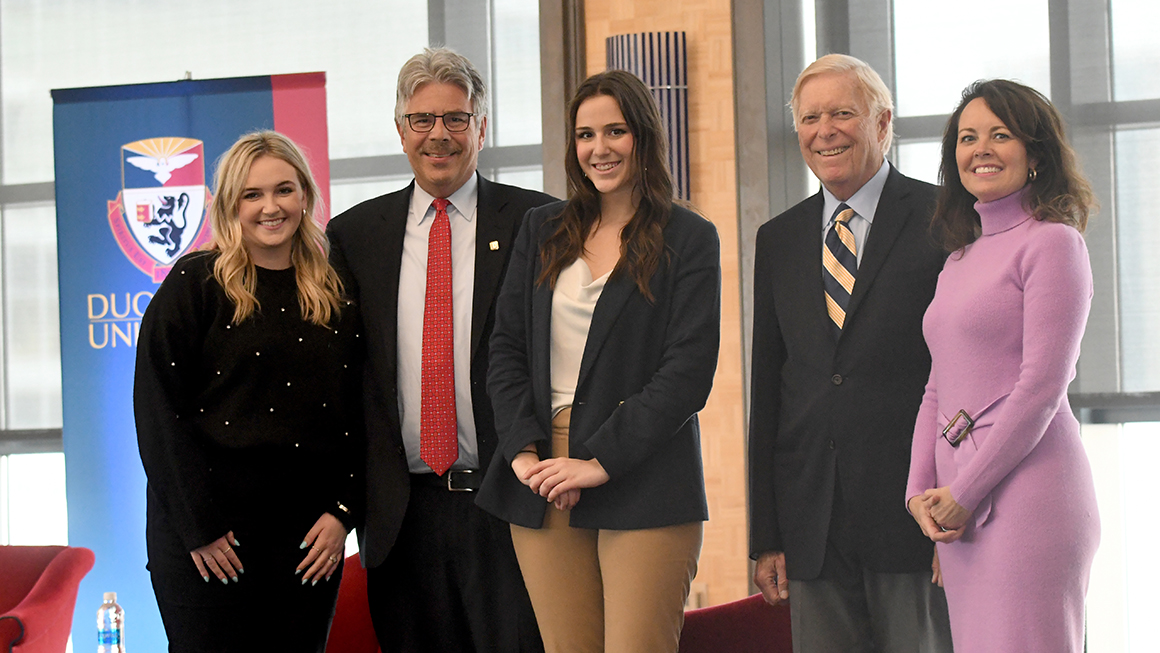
[[906, 80, 1100, 653]]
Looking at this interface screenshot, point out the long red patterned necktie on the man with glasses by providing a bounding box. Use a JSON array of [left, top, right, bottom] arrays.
[[419, 198, 459, 476]]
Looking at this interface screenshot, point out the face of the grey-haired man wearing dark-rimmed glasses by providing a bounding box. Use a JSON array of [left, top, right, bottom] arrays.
[[396, 81, 487, 197]]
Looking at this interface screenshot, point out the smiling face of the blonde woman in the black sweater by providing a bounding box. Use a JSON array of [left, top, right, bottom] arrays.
[[238, 155, 305, 269]]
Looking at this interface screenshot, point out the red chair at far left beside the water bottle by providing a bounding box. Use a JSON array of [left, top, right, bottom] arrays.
[[0, 546, 95, 653]]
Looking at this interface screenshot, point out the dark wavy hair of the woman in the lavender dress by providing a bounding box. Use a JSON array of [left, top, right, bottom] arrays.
[[931, 79, 1096, 252]]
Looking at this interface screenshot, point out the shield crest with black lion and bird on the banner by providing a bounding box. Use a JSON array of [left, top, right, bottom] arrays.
[[108, 137, 213, 283]]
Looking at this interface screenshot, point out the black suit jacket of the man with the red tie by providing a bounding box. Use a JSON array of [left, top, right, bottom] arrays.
[[326, 176, 556, 567]]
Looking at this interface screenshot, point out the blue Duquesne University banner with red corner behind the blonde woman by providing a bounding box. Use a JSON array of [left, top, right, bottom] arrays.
[[52, 73, 329, 653]]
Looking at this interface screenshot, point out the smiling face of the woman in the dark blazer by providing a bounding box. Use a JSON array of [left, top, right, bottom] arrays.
[[573, 95, 636, 196]]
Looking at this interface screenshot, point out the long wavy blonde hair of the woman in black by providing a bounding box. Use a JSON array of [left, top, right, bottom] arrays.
[[206, 131, 342, 325]]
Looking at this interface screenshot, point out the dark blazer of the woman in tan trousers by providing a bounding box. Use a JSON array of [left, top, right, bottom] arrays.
[[476, 202, 720, 530]]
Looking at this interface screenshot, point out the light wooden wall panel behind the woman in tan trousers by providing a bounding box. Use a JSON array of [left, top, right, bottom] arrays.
[[585, 0, 749, 604]]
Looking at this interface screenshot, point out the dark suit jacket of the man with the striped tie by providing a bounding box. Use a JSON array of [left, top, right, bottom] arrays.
[[749, 167, 945, 580]]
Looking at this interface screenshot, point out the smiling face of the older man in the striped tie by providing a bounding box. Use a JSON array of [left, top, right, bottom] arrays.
[[797, 73, 891, 201]]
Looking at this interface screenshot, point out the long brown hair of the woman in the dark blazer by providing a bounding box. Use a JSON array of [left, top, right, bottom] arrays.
[[537, 71, 673, 302]]
